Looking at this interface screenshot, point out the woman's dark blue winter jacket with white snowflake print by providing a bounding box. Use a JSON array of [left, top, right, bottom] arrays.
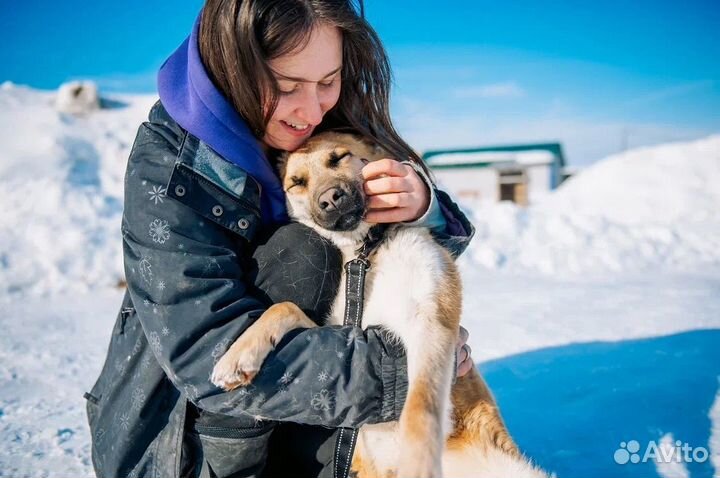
[[86, 102, 472, 478]]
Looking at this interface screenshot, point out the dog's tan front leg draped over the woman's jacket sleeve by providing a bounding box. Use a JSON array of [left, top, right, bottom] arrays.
[[210, 302, 316, 390]]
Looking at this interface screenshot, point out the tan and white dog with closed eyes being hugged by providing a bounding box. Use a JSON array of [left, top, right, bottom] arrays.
[[211, 132, 547, 478]]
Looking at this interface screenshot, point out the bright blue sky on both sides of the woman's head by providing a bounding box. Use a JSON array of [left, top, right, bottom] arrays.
[[0, 0, 720, 165]]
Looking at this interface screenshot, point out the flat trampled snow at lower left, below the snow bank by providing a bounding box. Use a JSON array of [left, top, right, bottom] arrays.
[[0, 289, 121, 478]]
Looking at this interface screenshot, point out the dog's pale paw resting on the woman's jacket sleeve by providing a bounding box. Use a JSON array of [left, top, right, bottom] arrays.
[[210, 340, 272, 391]]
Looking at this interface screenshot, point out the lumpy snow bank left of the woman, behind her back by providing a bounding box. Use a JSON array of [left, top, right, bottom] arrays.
[[0, 83, 155, 298]]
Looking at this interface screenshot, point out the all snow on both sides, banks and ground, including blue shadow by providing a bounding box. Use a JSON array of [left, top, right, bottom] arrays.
[[0, 82, 720, 478]]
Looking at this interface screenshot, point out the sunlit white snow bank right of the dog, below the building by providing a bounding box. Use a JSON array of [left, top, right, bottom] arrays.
[[466, 135, 720, 274]]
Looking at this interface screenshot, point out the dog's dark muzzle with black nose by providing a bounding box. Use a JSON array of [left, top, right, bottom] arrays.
[[313, 183, 365, 231]]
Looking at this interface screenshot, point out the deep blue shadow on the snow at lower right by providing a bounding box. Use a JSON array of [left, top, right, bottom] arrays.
[[478, 329, 720, 478]]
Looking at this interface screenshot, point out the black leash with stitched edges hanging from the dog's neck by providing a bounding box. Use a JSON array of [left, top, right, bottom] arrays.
[[333, 224, 388, 478]]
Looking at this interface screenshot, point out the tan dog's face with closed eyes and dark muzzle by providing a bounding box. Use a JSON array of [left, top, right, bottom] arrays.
[[278, 132, 385, 238]]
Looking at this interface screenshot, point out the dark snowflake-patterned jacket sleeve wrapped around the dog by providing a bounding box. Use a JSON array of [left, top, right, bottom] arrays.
[[123, 118, 407, 427]]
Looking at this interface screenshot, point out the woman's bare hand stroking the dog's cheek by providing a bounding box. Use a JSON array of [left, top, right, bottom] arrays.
[[362, 159, 430, 223]]
